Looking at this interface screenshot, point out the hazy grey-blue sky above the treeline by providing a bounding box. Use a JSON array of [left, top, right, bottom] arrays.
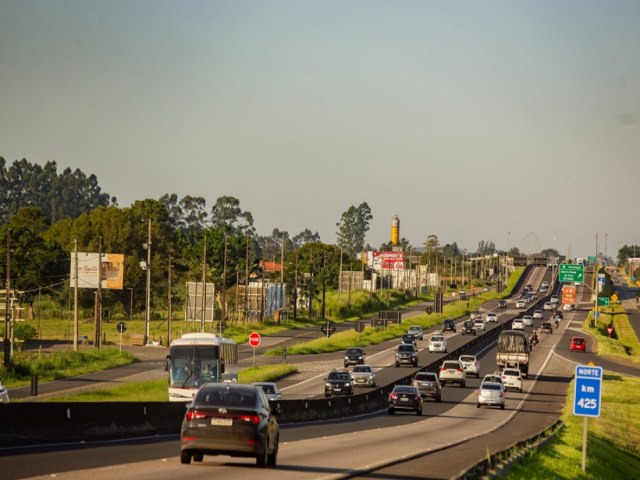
[[0, 0, 640, 256]]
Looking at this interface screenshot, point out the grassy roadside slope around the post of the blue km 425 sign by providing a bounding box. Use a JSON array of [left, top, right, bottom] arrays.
[[506, 373, 640, 480]]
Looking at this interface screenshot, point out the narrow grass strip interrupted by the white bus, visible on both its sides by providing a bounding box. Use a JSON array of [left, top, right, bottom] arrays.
[[38, 364, 298, 402]]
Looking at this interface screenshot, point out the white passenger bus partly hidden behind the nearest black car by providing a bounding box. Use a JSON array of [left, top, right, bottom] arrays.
[[165, 333, 238, 402]]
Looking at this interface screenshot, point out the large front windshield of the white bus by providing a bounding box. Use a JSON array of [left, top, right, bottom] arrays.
[[169, 345, 221, 388]]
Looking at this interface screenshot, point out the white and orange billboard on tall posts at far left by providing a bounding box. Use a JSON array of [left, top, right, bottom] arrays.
[[71, 252, 124, 290]]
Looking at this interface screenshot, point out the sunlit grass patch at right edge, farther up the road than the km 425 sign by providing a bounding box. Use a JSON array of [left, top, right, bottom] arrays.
[[582, 305, 640, 363]]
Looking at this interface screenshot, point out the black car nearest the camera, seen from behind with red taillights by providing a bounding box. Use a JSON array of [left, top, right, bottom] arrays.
[[180, 383, 280, 467]]
